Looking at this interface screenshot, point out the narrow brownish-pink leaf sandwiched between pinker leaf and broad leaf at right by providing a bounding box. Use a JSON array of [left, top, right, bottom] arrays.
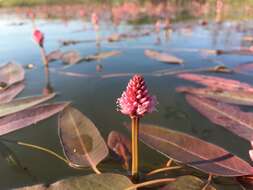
[[176, 87, 253, 106]]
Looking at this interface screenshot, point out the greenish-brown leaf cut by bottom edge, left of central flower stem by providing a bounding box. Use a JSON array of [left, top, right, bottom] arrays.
[[16, 173, 133, 190]]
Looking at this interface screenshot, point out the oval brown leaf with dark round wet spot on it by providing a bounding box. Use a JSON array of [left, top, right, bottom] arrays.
[[59, 107, 108, 167]]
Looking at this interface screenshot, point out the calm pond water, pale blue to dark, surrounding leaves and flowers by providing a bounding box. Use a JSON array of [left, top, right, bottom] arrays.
[[0, 2, 253, 189]]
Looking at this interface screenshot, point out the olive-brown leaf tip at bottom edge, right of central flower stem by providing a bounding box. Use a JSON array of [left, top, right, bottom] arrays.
[[161, 175, 215, 190]]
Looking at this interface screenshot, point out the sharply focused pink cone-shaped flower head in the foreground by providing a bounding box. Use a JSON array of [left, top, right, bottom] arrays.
[[117, 75, 157, 117]]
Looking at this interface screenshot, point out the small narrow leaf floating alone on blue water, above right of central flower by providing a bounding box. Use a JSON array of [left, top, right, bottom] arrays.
[[144, 50, 184, 64]]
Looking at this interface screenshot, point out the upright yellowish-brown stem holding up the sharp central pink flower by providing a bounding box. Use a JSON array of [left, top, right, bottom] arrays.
[[131, 117, 139, 178]]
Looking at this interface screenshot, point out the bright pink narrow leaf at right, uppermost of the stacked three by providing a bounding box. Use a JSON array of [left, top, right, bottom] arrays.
[[177, 73, 253, 92]]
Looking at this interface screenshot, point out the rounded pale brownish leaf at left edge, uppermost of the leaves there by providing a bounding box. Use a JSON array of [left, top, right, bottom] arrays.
[[0, 63, 25, 87]]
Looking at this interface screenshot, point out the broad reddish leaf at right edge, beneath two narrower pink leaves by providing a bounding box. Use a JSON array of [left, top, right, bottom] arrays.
[[186, 95, 253, 141]]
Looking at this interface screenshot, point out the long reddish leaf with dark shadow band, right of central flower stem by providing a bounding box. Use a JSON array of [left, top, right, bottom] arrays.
[[131, 124, 253, 176]]
